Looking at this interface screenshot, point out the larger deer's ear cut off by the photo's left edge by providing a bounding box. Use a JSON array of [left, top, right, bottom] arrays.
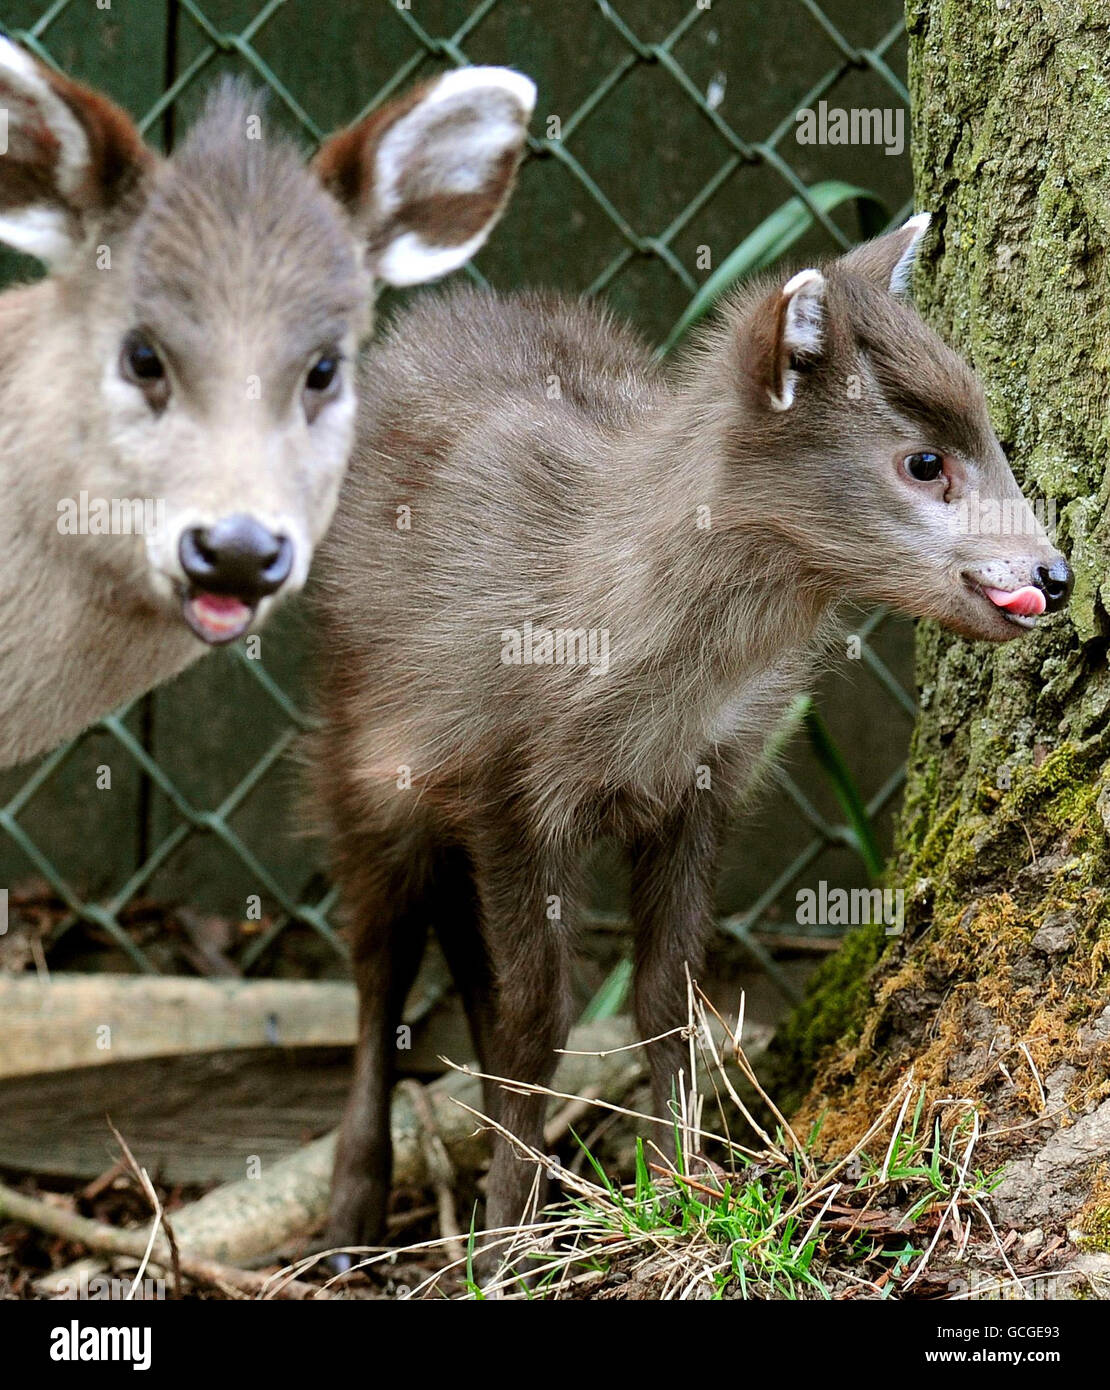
[[0, 39, 154, 265]]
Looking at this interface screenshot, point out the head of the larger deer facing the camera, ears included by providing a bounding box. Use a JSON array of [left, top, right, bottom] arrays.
[[0, 40, 535, 645]]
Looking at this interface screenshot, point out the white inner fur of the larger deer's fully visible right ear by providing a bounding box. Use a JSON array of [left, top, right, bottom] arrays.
[[375, 68, 536, 285]]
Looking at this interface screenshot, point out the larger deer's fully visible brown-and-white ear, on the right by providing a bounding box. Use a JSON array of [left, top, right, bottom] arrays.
[[313, 68, 536, 285]]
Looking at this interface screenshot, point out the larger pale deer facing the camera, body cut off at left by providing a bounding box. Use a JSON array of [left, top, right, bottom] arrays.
[[0, 40, 535, 765]]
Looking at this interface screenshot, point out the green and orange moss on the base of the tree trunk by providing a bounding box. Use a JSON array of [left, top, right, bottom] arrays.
[[771, 744, 1110, 1141]]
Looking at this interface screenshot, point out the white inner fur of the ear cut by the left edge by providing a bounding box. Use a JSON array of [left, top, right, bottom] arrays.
[[0, 39, 89, 264]]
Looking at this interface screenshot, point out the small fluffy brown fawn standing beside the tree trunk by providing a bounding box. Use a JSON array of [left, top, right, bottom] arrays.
[[313, 217, 1071, 1244]]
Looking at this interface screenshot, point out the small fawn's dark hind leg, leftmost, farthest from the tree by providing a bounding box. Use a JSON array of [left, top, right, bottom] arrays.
[[326, 835, 433, 1245]]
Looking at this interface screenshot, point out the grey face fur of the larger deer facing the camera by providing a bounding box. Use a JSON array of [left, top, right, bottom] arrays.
[[92, 89, 371, 639]]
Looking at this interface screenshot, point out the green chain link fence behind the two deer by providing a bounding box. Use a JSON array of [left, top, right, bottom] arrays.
[[0, 0, 914, 990]]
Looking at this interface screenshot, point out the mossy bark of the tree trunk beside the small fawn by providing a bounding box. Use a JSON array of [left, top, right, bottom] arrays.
[[778, 0, 1110, 1237]]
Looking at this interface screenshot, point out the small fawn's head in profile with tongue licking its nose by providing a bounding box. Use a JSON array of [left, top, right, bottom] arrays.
[[734, 215, 1071, 641]]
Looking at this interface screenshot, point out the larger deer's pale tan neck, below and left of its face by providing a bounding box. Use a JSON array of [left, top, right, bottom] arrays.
[[0, 281, 196, 766]]
